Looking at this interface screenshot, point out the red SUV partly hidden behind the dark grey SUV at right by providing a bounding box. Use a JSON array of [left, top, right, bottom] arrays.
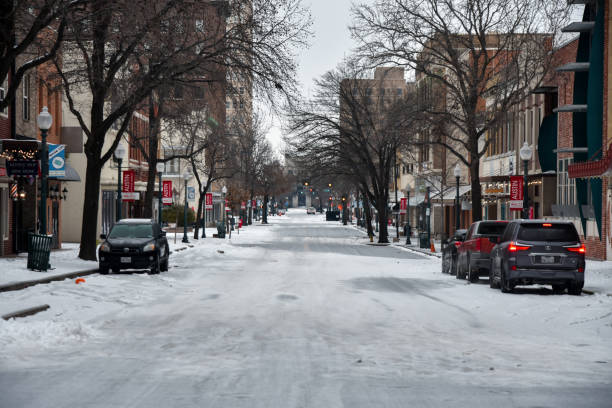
[[456, 221, 508, 282]]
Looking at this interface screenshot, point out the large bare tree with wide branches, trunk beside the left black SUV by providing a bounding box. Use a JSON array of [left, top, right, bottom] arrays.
[[56, 0, 310, 259]]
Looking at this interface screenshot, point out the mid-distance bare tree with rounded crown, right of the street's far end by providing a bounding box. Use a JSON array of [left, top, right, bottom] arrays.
[[291, 65, 414, 243]]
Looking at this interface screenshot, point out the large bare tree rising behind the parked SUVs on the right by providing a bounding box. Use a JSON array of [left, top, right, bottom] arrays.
[[352, 0, 567, 221]]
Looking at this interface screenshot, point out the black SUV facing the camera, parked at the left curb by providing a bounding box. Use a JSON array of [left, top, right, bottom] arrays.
[[98, 218, 170, 274]]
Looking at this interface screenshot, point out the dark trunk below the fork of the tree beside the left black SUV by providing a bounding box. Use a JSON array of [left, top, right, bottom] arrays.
[[79, 158, 102, 261]]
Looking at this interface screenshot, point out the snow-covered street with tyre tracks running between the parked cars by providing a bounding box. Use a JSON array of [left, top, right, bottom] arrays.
[[0, 209, 612, 408]]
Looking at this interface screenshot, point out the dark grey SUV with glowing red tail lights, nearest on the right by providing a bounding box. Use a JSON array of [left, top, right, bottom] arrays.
[[489, 220, 586, 295]]
